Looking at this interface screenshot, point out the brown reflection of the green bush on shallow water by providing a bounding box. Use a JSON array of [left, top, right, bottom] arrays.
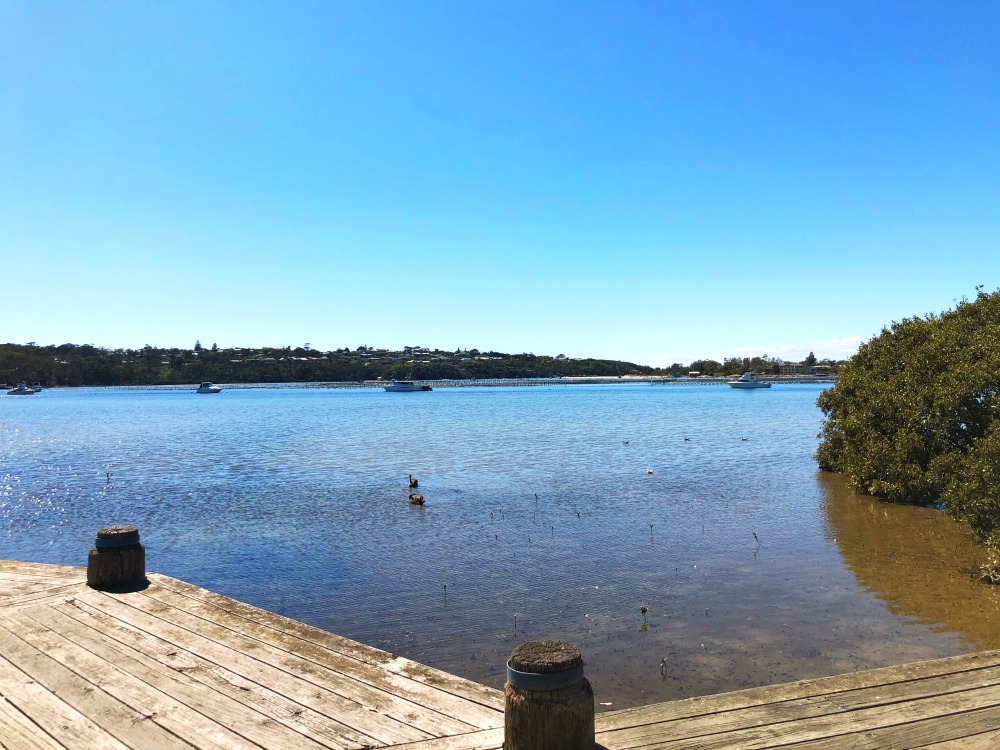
[[819, 474, 1000, 650]]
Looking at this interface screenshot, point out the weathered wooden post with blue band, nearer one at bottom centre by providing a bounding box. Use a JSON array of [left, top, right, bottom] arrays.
[[503, 641, 594, 750]]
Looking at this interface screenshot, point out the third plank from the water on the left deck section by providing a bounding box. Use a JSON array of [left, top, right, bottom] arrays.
[[70, 590, 433, 744]]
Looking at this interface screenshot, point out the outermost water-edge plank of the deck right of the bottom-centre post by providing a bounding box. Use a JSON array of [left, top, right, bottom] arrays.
[[597, 651, 1000, 732]]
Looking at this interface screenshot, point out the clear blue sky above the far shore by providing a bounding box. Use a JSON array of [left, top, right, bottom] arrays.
[[0, 0, 1000, 364]]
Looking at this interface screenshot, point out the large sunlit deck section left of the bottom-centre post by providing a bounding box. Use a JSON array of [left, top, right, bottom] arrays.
[[0, 562, 503, 750]]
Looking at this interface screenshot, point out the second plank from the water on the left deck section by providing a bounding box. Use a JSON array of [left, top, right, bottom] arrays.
[[122, 587, 484, 739]]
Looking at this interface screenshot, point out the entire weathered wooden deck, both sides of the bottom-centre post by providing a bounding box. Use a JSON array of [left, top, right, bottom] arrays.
[[0, 561, 1000, 750]]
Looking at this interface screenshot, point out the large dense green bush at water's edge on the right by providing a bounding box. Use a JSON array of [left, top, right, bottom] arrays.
[[816, 287, 1000, 568]]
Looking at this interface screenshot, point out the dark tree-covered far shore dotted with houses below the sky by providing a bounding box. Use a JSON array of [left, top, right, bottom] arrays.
[[0, 342, 843, 388]]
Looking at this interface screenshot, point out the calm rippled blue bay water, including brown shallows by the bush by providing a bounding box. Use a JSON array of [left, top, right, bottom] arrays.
[[0, 384, 1000, 708]]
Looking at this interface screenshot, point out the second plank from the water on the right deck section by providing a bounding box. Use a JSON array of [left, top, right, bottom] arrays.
[[602, 666, 1000, 747]]
